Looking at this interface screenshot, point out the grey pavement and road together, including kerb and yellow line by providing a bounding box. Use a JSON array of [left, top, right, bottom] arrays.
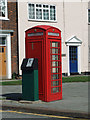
[[1, 82, 88, 120]]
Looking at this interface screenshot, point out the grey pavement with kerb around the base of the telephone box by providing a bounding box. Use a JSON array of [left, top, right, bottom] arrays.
[[0, 82, 90, 118]]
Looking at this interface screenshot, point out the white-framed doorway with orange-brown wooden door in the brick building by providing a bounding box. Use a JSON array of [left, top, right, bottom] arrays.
[[0, 33, 12, 79]]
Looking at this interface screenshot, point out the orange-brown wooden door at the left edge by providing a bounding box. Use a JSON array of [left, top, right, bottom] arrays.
[[0, 46, 6, 77]]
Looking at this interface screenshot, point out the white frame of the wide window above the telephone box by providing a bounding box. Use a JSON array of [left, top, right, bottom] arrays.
[[27, 2, 57, 22]]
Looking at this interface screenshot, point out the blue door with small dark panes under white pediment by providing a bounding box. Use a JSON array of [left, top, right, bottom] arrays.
[[69, 46, 78, 73]]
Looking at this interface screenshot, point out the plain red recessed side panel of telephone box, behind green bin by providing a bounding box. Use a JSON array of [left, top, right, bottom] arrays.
[[26, 41, 43, 94]]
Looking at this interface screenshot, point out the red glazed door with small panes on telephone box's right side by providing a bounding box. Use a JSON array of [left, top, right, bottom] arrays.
[[49, 40, 62, 100]]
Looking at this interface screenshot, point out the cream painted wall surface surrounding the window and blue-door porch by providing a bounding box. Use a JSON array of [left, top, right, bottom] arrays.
[[18, 0, 88, 73]]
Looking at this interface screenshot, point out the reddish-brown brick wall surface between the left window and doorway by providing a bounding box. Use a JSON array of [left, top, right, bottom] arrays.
[[0, 0, 18, 73]]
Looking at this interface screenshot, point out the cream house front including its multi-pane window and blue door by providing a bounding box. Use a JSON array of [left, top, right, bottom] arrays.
[[18, 0, 90, 76]]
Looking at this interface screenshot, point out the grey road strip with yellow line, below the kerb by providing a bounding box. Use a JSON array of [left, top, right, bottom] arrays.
[[0, 110, 86, 120]]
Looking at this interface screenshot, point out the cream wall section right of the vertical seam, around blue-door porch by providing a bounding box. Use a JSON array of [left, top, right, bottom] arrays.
[[63, 2, 88, 72]]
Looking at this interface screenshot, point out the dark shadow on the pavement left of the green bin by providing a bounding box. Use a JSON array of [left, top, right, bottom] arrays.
[[2, 93, 22, 101]]
